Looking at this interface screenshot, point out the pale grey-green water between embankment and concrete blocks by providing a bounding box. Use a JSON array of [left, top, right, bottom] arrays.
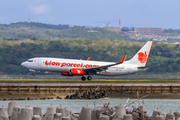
[[0, 99, 180, 115]]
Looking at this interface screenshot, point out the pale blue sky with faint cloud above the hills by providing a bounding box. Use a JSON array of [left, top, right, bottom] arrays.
[[0, 0, 180, 29]]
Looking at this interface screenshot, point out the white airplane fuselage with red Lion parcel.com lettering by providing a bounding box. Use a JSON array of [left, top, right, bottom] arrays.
[[21, 57, 146, 76]]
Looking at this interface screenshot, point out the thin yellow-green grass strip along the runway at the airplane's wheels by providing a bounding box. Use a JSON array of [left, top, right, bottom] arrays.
[[0, 79, 180, 82]]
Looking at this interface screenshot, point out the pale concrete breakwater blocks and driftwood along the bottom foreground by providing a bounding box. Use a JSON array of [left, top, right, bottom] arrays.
[[0, 95, 180, 120]]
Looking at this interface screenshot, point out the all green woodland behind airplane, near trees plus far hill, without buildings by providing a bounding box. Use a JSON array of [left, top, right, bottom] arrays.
[[0, 22, 180, 74]]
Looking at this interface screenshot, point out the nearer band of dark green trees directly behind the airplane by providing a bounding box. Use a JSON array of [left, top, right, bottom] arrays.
[[0, 39, 180, 74]]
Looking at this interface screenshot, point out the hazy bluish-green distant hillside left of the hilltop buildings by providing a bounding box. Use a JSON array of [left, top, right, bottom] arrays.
[[0, 22, 129, 40]]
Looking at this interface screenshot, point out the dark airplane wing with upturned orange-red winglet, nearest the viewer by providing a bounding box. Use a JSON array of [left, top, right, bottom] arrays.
[[83, 54, 127, 73]]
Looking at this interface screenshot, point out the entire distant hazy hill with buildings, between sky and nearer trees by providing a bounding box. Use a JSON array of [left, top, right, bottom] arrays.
[[0, 22, 180, 42]]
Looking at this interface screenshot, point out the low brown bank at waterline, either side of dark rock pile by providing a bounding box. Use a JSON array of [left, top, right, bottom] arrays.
[[0, 92, 180, 101]]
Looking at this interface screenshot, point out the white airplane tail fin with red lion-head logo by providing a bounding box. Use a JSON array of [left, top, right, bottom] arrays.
[[127, 41, 153, 66]]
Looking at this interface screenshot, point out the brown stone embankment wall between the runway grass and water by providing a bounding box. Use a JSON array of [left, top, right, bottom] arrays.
[[0, 81, 180, 100]]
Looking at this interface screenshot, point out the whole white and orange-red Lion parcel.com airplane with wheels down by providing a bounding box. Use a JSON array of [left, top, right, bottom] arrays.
[[21, 41, 153, 81]]
